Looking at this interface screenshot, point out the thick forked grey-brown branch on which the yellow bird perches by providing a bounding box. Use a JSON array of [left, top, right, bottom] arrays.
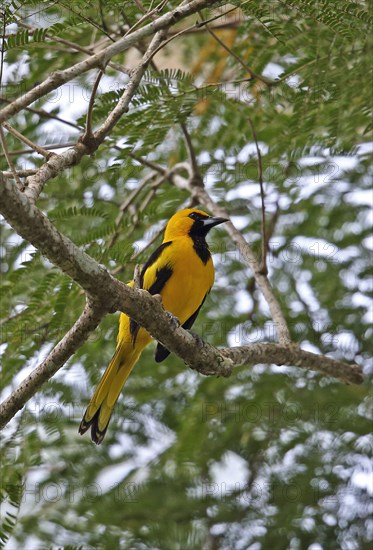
[[0, 175, 362, 426]]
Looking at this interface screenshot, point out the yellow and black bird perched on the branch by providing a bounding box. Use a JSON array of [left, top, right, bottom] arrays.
[[79, 208, 227, 445]]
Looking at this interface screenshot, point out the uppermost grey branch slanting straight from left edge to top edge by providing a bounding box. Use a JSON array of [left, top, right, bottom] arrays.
[[0, 0, 218, 124]]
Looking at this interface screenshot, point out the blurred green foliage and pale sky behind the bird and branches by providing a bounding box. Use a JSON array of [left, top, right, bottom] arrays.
[[0, 0, 373, 550]]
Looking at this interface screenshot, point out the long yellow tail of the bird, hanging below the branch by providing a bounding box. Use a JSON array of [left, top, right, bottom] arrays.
[[79, 338, 150, 445]]
